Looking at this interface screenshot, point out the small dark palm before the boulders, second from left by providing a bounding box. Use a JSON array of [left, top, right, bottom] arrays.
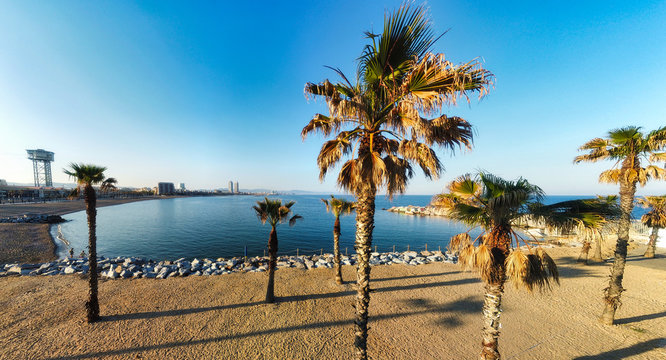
[[252, 198, 302, 303]]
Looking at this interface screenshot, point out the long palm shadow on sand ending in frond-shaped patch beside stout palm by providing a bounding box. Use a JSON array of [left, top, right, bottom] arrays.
[[46, 297, 482, 360]]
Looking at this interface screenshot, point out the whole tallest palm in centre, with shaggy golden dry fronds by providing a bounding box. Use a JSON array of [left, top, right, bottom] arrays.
[[301, 4, 493, 359]]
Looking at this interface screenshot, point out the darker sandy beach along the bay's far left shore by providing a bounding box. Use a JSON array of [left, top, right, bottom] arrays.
[[0, 197, 159, 264]]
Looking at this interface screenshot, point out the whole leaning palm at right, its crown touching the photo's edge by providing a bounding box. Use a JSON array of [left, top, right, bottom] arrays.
[[574, 126, 666, 325]]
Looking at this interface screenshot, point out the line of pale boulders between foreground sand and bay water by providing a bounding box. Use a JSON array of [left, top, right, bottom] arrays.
[[0, 251, 457, 279]]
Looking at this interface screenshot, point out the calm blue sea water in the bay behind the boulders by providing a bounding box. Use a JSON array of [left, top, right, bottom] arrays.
[[52, 195, 640, 260]]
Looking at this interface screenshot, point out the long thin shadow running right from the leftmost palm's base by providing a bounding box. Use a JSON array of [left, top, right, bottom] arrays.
[[100, 278, 480, 322]]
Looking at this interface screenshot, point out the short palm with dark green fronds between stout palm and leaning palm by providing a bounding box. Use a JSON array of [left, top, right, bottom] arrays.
[[530, 195, 620, 264]]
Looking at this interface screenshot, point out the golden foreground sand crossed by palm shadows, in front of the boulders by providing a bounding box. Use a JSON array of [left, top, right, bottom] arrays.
[[0, 248, 666, 359]]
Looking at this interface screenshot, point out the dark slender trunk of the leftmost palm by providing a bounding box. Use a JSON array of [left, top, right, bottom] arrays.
[[84, 185, 99, 323]]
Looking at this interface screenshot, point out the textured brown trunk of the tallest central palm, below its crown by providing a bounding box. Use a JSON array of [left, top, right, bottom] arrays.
[[354, 186, 377, 360]]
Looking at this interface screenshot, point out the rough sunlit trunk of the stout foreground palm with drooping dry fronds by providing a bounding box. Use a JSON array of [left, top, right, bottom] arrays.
[[479, 281, 504, 360]]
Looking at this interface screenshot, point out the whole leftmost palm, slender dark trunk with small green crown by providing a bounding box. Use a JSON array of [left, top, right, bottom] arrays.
[[63, 163, 115, 323]]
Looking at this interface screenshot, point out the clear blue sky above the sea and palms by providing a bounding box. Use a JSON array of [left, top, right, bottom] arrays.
[[0, 0, 666, 194]]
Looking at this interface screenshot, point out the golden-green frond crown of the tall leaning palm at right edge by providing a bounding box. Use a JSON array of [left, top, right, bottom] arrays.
[[574, 126, 666, 186]]
